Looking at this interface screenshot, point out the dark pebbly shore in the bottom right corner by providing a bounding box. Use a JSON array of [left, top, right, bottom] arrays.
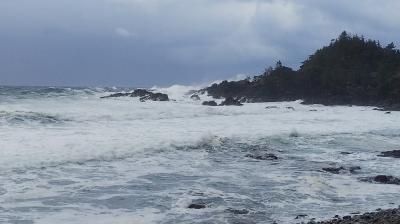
[[308, 208, 400, 224]]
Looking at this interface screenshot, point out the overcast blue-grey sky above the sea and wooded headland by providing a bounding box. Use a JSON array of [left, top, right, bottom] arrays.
[[0, 0, 400, 86]]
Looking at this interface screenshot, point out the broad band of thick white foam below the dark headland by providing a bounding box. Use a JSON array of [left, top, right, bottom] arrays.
[[0, 86, 400, 169]]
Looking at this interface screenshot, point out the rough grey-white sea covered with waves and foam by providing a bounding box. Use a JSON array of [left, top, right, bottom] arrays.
[[0, 85, 400, 224]]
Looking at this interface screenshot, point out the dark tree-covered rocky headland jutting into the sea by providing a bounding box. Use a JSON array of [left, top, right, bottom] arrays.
[[201, 31, 400, 110]]
